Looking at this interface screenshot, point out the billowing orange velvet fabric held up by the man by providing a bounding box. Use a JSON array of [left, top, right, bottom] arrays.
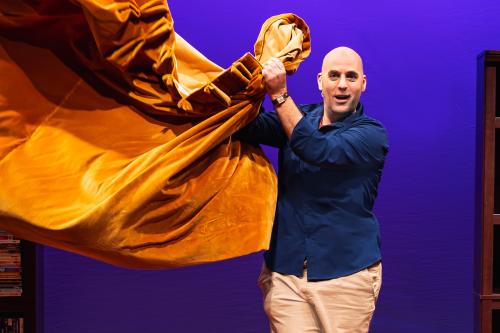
[[0, 0, 310, 268]]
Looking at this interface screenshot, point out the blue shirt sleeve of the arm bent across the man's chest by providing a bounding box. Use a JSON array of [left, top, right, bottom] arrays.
[[290, 118, 389, 167]]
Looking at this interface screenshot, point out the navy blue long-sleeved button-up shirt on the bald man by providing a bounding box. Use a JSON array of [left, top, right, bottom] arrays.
[[238, 103, 388, 280]]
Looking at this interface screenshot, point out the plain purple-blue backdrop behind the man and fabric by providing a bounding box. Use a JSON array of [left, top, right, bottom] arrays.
[[39, 0, 500, 333]]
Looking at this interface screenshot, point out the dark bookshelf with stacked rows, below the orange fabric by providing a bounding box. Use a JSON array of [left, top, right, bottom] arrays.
[[0, 231, 42, 333]]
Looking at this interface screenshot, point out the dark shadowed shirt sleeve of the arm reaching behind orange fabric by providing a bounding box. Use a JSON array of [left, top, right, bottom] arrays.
[[235, 109, 287, 148]]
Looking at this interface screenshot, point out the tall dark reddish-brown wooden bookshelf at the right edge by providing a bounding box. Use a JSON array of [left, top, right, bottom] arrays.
[[474, 51, 500, 333]]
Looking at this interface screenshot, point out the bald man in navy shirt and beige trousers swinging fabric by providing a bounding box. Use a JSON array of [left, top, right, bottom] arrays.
[[238, 47, 388, 333]]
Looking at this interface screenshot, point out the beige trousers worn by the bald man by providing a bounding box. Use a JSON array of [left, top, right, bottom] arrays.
[[259, 263, 382, 333]]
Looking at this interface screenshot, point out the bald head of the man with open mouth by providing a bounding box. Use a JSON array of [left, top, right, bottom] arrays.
[[318, 47, 366, 113]]
